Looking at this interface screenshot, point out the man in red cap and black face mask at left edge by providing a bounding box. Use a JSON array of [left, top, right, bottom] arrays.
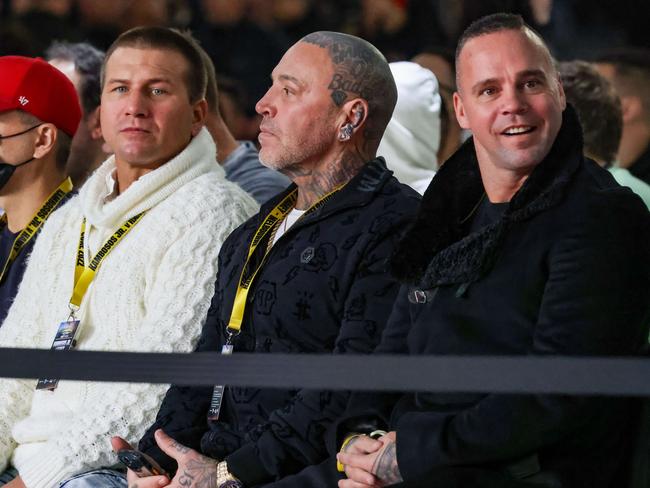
[[0, 56, 81, 324]]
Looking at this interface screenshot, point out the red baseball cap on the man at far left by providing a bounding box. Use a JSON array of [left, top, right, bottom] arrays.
[[0, 56, 81, 137]]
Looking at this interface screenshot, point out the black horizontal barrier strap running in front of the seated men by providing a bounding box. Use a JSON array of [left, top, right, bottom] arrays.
[[0, 348, 650, 397]]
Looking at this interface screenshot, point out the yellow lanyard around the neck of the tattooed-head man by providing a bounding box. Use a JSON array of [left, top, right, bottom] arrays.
[[226, 185, 343, 343]]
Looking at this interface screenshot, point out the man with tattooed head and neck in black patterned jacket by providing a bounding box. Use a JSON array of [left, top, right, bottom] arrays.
[[73, 32, 419, 488]]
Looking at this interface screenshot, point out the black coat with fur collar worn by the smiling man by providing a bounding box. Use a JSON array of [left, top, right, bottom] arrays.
[[338, 108, 650, 488]]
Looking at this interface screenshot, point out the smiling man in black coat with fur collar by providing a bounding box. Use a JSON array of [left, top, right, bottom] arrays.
[[334, 14, 650, 488]]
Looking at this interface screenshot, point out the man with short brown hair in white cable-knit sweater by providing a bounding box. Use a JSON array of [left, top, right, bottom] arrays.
[[0, 27, 257, 488]]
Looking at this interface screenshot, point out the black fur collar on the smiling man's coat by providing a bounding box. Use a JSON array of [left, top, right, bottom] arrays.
[[391, 106, 582, 289]]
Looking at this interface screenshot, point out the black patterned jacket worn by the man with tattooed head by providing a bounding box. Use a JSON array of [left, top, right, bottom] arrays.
[[140, 158, 419, 486]]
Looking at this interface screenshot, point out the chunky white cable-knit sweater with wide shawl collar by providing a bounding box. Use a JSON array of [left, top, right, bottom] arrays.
[[0, 129, 257, 488]]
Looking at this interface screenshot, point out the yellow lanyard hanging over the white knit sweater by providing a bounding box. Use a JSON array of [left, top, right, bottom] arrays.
[[70, 212, 144, 312]]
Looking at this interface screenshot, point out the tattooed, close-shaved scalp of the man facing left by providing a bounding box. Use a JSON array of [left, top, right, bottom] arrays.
[[300, 31, 397, 149]]
